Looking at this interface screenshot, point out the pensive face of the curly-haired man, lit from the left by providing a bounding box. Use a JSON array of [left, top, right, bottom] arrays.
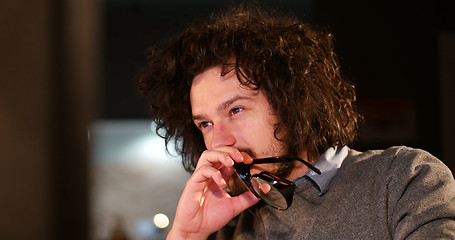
[[190, 67, 292, 176]]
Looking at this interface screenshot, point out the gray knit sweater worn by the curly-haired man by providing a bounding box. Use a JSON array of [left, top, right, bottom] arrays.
[[216, 147, 455, 239]]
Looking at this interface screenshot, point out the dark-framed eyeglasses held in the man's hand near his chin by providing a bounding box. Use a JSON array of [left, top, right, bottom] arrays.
[[228, 157, 321, 210]]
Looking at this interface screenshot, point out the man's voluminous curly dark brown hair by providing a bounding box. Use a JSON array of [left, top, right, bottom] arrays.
[[138, 5, 361, 172]]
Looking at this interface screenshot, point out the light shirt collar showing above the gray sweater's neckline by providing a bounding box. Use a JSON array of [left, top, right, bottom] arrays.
[[293, 146, 349, 195]]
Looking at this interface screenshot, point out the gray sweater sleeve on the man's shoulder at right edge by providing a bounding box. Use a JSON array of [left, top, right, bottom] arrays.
[[388, 148, 455, 239]]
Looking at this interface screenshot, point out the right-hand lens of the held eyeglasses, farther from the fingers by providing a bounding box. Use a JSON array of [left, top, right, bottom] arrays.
[[251, 177, 288, 210]]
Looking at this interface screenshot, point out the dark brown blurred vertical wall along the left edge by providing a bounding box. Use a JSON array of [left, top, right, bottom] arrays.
[[0, 0, 100, 240]]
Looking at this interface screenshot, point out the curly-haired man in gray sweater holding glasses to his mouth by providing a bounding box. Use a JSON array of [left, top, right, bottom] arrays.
[[139, 6, 455, 239]]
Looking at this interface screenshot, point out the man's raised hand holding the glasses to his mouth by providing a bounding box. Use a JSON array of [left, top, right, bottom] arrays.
[[167, 147, 259, 239]]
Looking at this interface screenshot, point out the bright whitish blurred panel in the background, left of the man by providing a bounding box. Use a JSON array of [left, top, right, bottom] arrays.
[[89, 120, 189, 240]]
